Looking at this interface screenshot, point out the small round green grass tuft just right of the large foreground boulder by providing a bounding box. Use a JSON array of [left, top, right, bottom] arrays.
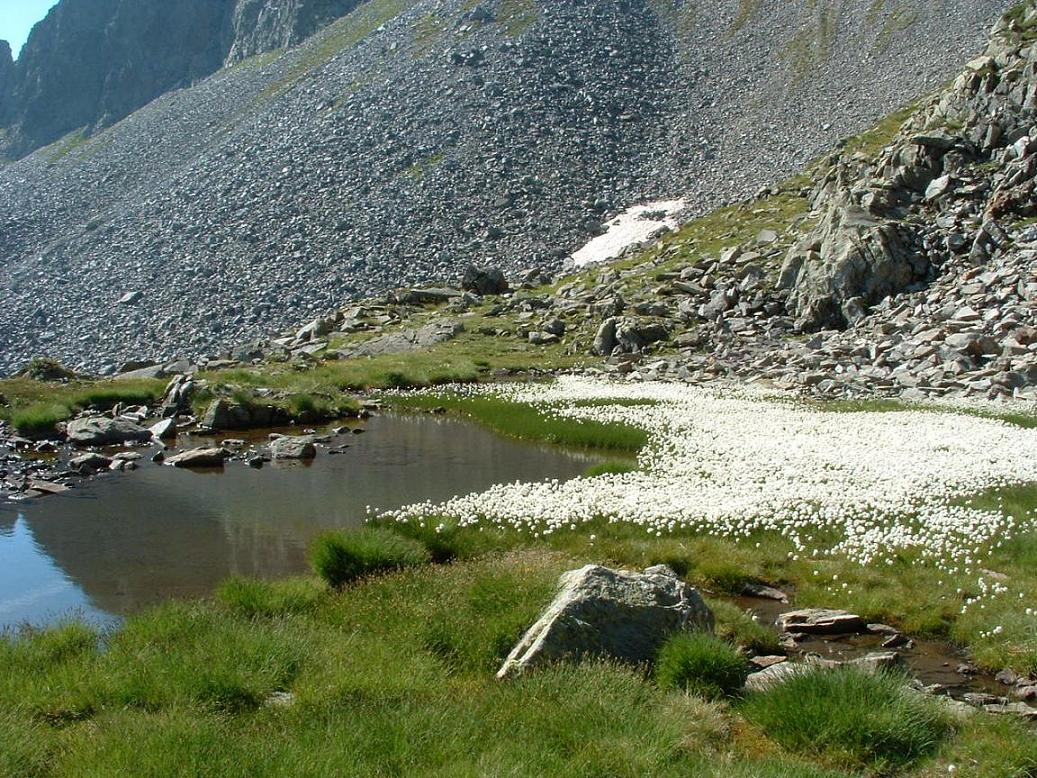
[[655, 632, 750, 700]]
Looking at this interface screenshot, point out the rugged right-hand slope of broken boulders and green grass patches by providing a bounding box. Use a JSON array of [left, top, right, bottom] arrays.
[[210, 0, 1037, 401]]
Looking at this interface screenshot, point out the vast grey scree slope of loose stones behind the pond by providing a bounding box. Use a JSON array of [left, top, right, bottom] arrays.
[[0, 0, 1004, 372]]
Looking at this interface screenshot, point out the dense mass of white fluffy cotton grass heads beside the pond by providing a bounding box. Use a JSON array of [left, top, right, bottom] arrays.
[[388, 378, 1037, 572]]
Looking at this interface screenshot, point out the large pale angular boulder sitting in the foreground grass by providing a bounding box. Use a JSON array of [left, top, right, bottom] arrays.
[[497, 564, 713, 678]]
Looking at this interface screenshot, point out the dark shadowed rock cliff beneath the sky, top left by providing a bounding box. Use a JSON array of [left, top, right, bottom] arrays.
[[0, 0, 359, 158]]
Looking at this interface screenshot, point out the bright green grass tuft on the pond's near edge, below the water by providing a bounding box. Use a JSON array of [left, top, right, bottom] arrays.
[[311, 527, 432, 589]]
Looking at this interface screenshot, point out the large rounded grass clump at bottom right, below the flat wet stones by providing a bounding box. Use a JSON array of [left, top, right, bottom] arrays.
[[741, 667, 951, 775]]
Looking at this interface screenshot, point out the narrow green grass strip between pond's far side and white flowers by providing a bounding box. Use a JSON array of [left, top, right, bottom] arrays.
[[390, 393, 648, 453]]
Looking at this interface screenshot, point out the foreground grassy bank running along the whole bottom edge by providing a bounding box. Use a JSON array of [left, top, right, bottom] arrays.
[[0, 550, 1037, 778]]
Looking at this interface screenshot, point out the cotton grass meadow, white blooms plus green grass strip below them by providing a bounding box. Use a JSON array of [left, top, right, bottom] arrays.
[[380, 377, 1037, 671]]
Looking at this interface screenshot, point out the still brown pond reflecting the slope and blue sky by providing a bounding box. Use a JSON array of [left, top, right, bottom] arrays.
[[0, 416, 598, 630]]
